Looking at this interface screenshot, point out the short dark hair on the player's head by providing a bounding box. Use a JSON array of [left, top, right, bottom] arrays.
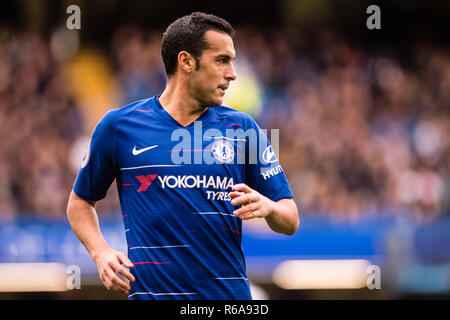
[[161, 12, 234, 77]]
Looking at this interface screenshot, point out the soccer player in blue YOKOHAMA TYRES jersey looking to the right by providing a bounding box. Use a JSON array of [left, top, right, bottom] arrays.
[[67, 12, 299, 300]]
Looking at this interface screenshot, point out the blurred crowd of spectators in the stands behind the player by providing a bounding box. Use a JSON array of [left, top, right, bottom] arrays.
[[0, 1, 450, 222]]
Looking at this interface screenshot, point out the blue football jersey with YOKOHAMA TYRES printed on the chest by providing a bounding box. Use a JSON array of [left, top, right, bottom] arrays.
[[74, 96, 293, 300]]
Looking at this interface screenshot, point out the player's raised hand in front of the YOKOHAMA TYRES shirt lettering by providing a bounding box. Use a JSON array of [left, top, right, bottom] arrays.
[[230, 183, 274, 220]]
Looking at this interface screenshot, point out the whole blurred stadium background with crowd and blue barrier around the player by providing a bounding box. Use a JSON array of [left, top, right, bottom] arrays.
[[0, 0, 450, 299]]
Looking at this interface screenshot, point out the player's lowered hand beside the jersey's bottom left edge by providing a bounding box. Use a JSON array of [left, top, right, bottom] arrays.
[[93, 248, 135, 294]]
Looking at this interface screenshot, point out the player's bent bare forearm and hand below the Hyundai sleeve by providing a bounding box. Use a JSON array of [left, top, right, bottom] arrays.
[[230, 183, 300, 235]]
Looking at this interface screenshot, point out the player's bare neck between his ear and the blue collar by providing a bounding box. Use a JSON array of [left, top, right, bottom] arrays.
[[159, 79, 208, 127]]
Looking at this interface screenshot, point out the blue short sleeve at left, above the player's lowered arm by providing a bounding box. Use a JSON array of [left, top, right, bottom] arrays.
[[73, 110, 117, 201]]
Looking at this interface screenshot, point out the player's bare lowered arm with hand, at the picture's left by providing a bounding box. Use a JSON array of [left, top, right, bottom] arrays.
[[67, 190, 135, 294]]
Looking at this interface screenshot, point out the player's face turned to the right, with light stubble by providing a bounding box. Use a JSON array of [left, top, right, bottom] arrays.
[[189, 30, 236, 107]]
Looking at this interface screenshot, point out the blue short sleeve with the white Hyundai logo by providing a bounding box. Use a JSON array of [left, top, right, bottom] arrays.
[[245, 118, 294, 201]]
